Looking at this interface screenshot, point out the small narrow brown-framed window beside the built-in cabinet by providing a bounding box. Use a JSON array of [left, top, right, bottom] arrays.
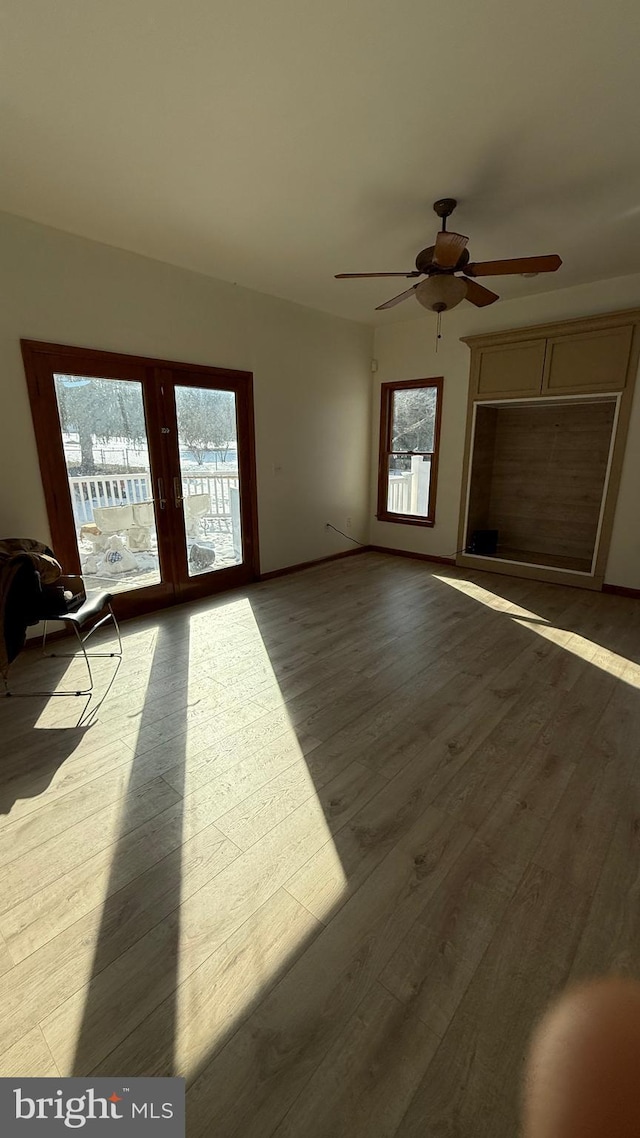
[[377, 378, 442, 526]]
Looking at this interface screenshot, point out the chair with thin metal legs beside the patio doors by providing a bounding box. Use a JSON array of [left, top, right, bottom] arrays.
[[6, 574, 122, 696]]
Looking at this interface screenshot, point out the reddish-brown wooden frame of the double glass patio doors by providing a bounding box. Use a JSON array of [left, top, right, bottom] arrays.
[[20, 339, 260, 617]]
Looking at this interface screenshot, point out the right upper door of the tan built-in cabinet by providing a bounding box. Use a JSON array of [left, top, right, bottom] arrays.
[[542, 324, 633, 395]]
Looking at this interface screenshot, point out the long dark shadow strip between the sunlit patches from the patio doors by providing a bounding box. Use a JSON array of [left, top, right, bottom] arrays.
[[69, 621, 189, 1075]]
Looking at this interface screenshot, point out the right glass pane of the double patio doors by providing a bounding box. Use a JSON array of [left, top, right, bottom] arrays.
[[173, 384, 243, 577]]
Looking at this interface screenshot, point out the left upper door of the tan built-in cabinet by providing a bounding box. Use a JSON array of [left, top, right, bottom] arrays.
[[471, 339, 545, 399]]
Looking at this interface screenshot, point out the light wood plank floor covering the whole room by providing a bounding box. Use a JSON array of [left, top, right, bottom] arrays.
[[0, 553, 640, 1138]]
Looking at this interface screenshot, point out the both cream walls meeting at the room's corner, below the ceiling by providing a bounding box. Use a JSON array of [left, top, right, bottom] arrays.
[[0, 214, 640, 588]]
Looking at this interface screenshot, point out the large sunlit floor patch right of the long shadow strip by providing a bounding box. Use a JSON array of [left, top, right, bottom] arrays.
[[169, 599, 346, 1077]]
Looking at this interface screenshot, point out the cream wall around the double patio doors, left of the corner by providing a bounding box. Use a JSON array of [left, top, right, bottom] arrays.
[[0, 214, 371, 571]]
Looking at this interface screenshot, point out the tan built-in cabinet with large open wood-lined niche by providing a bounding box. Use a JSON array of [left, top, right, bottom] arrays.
[[458, 311, 640, 588]]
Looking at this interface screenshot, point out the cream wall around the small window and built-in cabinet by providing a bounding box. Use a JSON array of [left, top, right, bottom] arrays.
[[370, 274, 640, 588]]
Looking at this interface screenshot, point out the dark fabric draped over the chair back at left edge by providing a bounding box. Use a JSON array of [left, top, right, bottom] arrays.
[[0, 537, 63, 678]]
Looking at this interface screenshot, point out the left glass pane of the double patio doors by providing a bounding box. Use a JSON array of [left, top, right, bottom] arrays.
[[54, 372, 162, 593]]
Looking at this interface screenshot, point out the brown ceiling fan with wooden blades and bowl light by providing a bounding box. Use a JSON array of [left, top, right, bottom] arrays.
[[336, 198, 563, 313]]
